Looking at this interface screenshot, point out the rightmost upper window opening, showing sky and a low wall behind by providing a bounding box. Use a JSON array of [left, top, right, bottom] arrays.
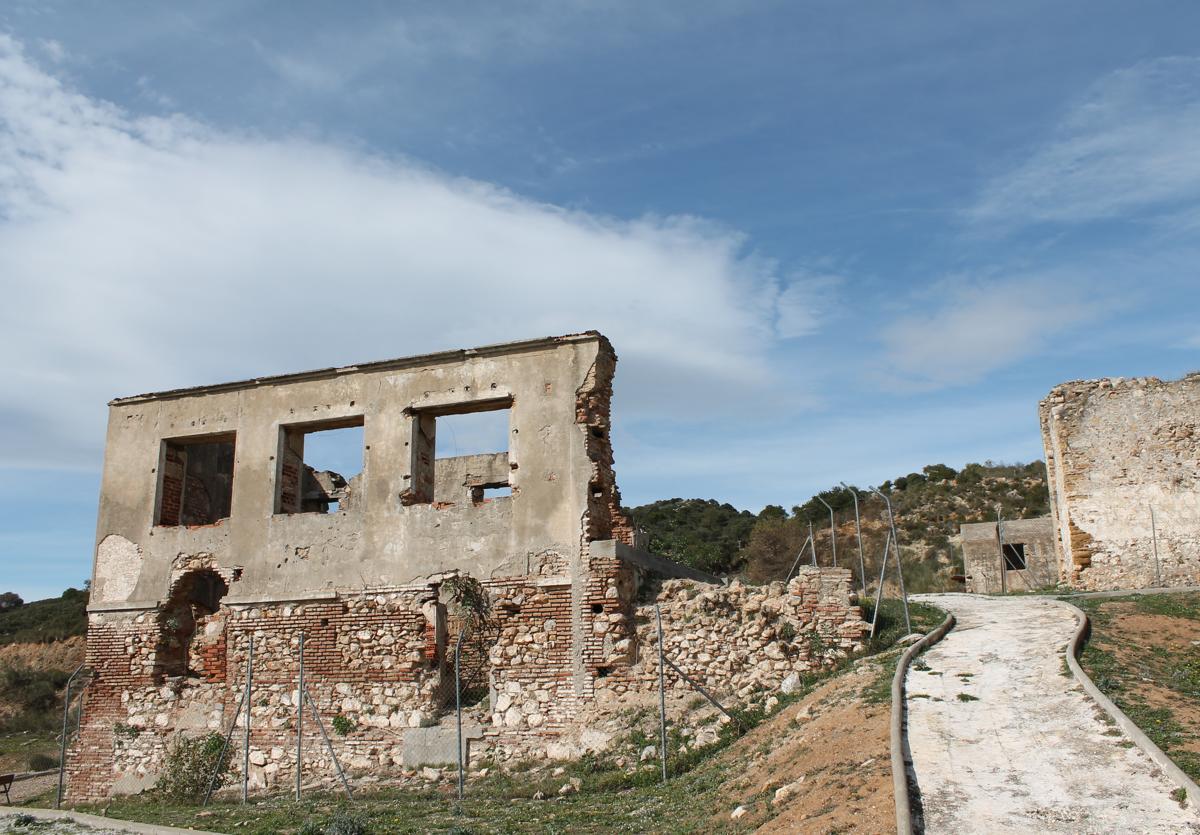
[[402, 400, 512, 505]]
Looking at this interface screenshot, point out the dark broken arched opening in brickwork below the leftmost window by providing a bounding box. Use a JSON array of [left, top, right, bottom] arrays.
[[154, 567, 229, 681]]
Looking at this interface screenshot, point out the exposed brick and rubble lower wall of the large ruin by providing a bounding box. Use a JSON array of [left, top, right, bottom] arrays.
[[68, 558, 869, 801]]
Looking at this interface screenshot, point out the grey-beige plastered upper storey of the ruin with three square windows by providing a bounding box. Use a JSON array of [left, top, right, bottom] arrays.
[[92, 331, 628, 607]]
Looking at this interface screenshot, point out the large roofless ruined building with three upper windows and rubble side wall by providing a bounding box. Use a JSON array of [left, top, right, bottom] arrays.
[[68, 332, 863, 800]]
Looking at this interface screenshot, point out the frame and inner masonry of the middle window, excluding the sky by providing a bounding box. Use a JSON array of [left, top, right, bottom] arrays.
[[272, 414, 367, 516]]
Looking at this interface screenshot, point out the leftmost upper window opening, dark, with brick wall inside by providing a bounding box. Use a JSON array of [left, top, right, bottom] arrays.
[[156, 434, 234, 525]]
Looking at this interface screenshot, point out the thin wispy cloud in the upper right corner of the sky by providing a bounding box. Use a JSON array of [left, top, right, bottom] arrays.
[[970, 58, 1200, 228]]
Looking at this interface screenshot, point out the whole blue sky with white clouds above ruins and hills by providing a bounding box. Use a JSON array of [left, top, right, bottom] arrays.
[[0, 0, 1200, 599]]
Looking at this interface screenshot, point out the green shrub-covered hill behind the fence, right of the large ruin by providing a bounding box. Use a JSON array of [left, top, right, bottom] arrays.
[[629, 461, 1049, 591]]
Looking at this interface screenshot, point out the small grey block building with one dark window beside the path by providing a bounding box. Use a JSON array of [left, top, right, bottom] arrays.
[[959, 516, 1058, 594]]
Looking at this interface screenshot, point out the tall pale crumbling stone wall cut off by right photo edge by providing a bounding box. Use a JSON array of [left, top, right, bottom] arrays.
[[1039, 373, 1200, 589]]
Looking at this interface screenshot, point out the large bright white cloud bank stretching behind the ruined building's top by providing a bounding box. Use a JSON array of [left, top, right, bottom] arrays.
[[0, 36, 811, 465]]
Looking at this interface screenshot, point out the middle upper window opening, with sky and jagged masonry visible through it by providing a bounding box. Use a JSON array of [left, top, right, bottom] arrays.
[[275, 416, 365, 513]]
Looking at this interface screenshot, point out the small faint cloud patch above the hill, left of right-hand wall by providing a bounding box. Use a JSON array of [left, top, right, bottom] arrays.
[[882, 272, 1104, 390]]
